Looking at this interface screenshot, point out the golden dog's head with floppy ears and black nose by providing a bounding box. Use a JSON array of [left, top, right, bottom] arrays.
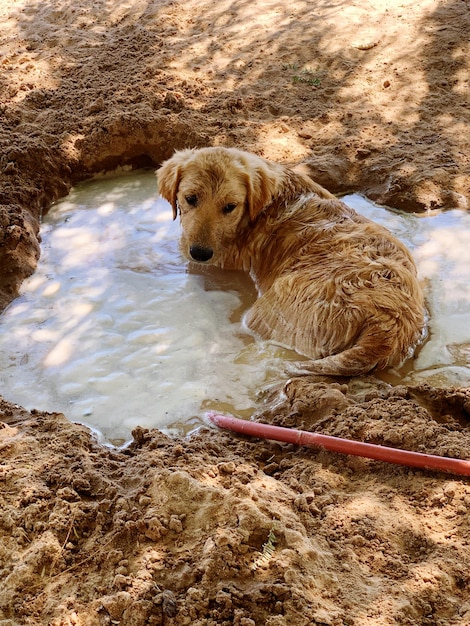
[[157, 148, 283, 265]]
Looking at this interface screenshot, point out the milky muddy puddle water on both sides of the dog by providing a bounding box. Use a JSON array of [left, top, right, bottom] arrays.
[[0, 173, 470, 444]]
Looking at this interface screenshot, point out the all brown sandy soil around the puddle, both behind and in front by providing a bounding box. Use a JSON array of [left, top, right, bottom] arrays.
[[0, 0, 470, 626]]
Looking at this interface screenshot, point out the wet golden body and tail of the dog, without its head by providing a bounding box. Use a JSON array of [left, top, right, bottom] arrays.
[[242, 194, 424, 375]]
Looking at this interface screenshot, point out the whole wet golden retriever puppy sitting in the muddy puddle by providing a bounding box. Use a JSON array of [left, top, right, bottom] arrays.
[[157, 148, 425, 376]]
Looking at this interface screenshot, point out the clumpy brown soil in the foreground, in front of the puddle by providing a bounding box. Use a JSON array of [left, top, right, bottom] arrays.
[[0, 379, 470, 626]]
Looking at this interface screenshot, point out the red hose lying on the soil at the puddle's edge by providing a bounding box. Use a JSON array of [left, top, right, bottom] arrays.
[[207, 412, 470, 476]]
